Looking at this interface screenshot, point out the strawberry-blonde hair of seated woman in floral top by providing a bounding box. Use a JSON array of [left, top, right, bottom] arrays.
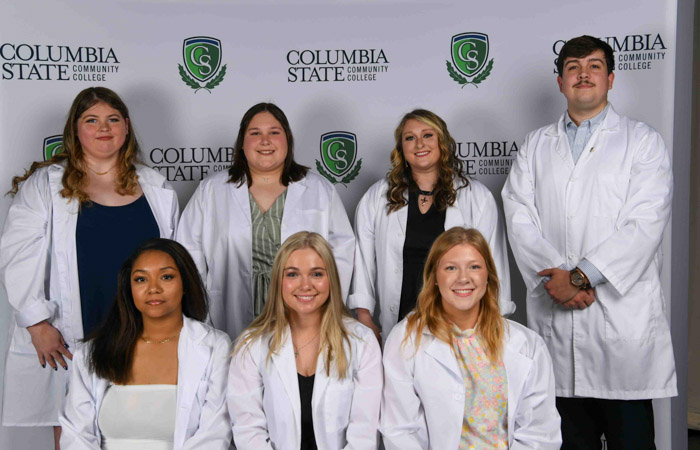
[[403, 227, 505, 364]]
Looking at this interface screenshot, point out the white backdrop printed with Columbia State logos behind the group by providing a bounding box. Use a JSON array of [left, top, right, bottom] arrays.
[[0, 0, 685, 449]]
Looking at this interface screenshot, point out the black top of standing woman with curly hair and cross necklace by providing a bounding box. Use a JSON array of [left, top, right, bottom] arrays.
[[399, 191, 447, 321]]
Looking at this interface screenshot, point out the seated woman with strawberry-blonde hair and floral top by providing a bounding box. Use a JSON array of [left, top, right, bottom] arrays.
[[380, 227, 561, 449]]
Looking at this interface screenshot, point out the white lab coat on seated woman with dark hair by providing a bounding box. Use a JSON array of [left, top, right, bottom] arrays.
[[59, 317, 231, 450]]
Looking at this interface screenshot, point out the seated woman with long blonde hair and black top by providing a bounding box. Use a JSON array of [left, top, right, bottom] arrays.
[[227, 231, 382, 450]]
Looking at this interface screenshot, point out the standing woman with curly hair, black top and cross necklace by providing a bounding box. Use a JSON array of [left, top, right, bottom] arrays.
[[348, 109, 515, 338]]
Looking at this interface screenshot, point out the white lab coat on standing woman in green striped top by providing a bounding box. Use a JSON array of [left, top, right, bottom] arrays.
[[177, 172, 355, 339]]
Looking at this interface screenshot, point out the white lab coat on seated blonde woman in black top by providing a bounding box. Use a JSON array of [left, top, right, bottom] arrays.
[[227, 320, 382, 450]]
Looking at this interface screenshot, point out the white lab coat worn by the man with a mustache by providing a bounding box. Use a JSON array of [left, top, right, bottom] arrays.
[[503, 107, 677, 399]]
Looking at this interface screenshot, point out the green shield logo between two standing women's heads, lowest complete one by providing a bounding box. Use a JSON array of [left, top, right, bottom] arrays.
[[316, 131, 362, 185]]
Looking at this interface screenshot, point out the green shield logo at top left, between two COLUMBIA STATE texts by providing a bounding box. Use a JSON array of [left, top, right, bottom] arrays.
[[177, 36, 226, 93]]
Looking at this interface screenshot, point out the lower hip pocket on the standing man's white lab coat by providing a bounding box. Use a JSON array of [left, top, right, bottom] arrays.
[[599, 281, 661, 339]]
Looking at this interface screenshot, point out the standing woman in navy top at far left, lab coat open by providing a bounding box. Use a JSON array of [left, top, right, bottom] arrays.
[[0, 87, 178, 447]]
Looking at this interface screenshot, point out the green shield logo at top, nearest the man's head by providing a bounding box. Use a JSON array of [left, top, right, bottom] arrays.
[[446, 32, 493, 88]]
